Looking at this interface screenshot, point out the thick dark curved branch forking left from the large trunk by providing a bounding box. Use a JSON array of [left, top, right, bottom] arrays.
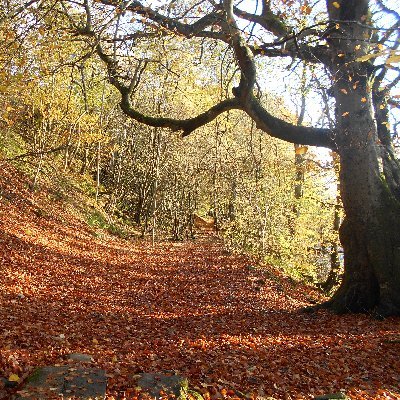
[[90, 0, 336, 149]]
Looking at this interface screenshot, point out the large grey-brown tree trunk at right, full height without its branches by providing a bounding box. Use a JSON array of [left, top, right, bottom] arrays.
[[320, 0, 400, 317]]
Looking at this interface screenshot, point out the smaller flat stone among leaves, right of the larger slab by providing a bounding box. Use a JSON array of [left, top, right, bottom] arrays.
[[137, 373, 189, 399]]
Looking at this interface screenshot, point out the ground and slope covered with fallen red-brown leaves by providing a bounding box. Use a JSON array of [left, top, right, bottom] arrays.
[[0, 163, 400, 399]]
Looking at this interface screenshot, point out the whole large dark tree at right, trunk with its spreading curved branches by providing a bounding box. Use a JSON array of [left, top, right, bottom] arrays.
[[54, 0, 400, 315]]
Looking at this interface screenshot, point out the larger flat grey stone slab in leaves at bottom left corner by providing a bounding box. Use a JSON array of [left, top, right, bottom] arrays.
[[16, 366, 107, 400]]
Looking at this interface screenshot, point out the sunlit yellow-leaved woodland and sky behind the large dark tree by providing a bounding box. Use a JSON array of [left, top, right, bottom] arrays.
[[0, 1, 398, 292]]
